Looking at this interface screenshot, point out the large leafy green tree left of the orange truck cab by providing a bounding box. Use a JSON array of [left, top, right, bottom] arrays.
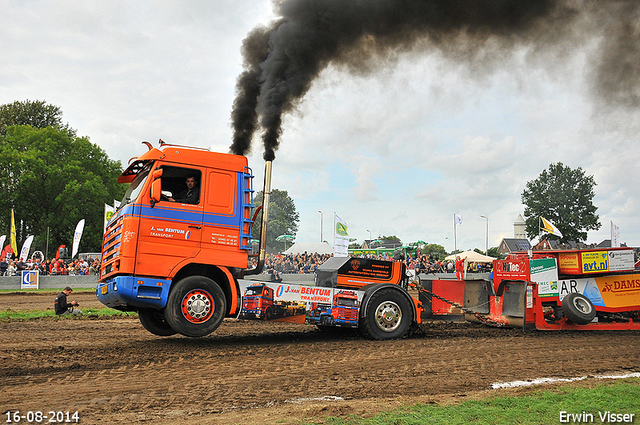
[[0, 125, 125, 257]]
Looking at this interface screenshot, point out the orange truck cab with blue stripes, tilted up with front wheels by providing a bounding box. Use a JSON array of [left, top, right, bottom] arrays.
[[97, 144, 253, 336]]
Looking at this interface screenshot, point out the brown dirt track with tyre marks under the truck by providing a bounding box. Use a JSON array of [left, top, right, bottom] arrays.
[[0, 293, 640, 424]]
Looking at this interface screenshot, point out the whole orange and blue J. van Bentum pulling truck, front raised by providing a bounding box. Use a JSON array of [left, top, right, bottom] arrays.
[[96, 141, 421, 339]]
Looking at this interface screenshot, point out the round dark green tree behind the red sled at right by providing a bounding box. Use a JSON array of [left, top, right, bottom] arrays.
[[522, 162, 602, 242]]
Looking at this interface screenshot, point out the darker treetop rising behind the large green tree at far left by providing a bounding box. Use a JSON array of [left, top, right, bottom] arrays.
[[0, 100, 76, 136]]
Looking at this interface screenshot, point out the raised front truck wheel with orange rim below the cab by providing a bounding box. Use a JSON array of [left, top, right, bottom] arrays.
[[164, 276, 227, 338]]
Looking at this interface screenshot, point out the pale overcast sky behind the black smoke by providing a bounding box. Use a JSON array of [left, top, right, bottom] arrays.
[[0, 0, 640, 251]]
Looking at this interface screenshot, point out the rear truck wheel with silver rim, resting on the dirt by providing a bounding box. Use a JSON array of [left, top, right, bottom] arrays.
[[360, 289, 412, 339]]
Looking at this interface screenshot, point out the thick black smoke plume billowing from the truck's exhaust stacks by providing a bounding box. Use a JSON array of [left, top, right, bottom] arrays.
[[230, 0, 640, 160]]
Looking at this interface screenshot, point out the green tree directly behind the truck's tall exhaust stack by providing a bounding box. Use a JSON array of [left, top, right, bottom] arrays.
[[251, 189, 300, 251]]
